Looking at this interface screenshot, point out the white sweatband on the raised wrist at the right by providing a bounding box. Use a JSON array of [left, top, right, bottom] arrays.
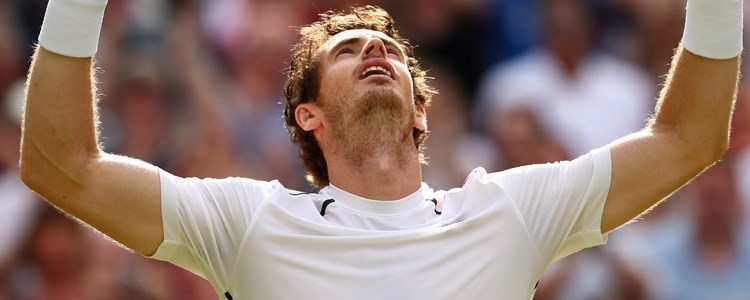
[[682, 0, 743, 59]]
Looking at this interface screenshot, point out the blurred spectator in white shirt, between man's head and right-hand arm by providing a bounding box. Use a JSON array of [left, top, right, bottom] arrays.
[[476, 0, 654, 157]]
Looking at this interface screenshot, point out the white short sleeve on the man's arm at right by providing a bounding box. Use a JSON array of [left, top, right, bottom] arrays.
[[491, 147, 612, 264]]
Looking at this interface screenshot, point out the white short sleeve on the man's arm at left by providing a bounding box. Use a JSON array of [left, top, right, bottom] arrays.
[[151, 170, 280, 288]]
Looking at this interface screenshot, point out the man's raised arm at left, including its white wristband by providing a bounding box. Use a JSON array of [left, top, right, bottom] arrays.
[[21, 0, 163, 255]]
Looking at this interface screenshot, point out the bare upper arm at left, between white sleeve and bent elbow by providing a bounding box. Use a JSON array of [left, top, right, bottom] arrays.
[[58, 154, 164, 255]]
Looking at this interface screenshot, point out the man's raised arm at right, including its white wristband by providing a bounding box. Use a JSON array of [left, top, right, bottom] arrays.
[[602, 0, 742, 232]]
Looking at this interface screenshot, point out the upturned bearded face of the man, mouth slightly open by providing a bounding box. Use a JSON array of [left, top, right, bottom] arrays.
[[302, 30, 425, 162]]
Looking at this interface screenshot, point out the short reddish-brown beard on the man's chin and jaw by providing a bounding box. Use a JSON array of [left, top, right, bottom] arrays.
[[323, 89, 415, 166]]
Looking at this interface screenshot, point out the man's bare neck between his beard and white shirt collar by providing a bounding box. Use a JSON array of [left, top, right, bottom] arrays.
[[326, 143, 422, 200]]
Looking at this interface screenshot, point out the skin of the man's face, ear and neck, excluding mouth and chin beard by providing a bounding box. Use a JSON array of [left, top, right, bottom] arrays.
[[295, 30, 426, 200]]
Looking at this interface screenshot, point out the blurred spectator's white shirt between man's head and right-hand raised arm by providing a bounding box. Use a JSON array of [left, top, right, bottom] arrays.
[[477, 49, 655, 157]]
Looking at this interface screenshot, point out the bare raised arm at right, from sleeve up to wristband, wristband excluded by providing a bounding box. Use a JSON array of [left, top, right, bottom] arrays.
[[602, 48, 739, 232]]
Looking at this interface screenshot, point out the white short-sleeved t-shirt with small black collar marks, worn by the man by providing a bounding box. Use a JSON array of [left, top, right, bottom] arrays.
[[153, 147, 611, 300]]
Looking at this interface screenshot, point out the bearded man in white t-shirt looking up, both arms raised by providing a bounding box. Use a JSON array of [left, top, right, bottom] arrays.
[[21, 0, 742, 299]]
